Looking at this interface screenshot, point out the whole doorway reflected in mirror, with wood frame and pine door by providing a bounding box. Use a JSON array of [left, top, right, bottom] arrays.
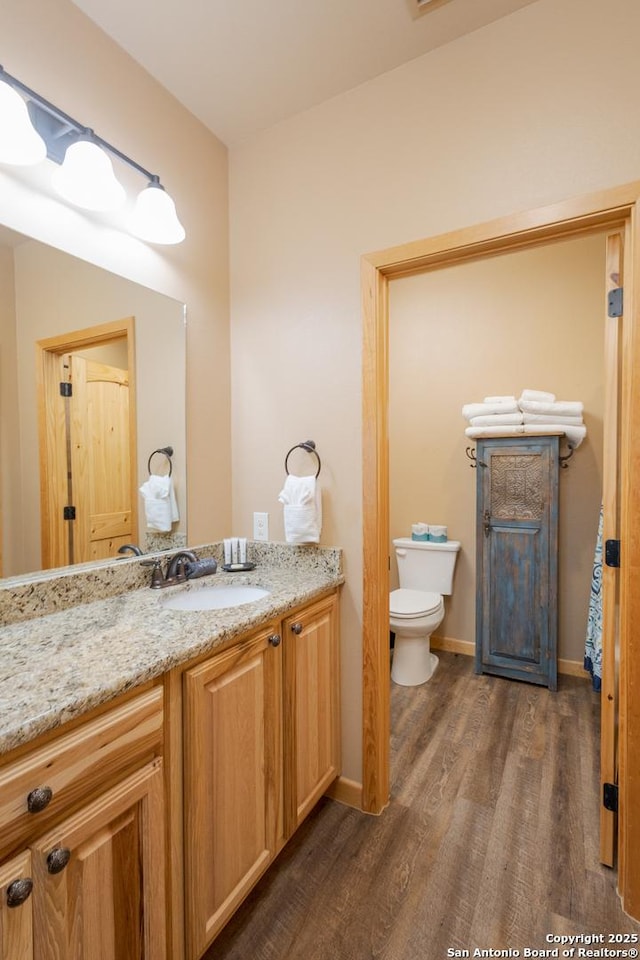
[[36, 317, 137, 569]]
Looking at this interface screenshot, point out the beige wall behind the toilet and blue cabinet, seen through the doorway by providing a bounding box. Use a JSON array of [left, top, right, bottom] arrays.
[[389, 236, 605, 664]]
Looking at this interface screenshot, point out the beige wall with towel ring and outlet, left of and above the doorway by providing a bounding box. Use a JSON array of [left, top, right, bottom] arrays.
[[230, 0, 640, 779]]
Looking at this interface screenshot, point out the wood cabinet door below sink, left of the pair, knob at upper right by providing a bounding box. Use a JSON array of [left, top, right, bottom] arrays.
[[184, 630, 282, 960]]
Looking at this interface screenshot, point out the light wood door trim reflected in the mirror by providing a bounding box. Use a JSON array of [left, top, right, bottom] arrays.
[[35, 317, 138, 570]]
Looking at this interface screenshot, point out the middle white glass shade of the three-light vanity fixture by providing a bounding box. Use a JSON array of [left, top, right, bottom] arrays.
[[51, 137, 125, 211]]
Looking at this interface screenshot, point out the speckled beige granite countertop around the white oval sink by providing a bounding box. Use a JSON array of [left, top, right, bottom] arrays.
[[0, 550, 344, 754]]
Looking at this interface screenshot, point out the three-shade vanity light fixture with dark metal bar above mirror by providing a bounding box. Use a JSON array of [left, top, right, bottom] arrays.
[[0, 66, 185, 244]]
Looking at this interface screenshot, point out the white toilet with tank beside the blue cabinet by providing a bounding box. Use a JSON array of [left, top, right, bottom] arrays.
[[389, 537, 460, 687]]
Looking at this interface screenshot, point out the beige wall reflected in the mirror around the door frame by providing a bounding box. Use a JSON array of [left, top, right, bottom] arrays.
[[8, 241, 187, 576]]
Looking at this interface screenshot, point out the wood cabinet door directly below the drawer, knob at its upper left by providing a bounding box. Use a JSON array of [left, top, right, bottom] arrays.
[[31, 760, 166, 960]]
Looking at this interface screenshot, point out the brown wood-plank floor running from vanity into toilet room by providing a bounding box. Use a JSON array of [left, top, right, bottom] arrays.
[[206, 652, 640, 960]]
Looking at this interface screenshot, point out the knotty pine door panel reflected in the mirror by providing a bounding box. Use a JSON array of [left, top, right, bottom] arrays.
[[67, 354, 135, 563]]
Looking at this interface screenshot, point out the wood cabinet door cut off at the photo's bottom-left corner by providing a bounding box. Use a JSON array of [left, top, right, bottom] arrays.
[[0, 850, 34, 960]]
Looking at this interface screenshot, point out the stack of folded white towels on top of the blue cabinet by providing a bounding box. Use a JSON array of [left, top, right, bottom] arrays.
[[462, 390, 587, 449]]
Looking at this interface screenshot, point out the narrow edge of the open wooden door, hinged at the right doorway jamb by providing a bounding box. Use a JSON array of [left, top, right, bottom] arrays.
[[600, 231, 624, 867]]
